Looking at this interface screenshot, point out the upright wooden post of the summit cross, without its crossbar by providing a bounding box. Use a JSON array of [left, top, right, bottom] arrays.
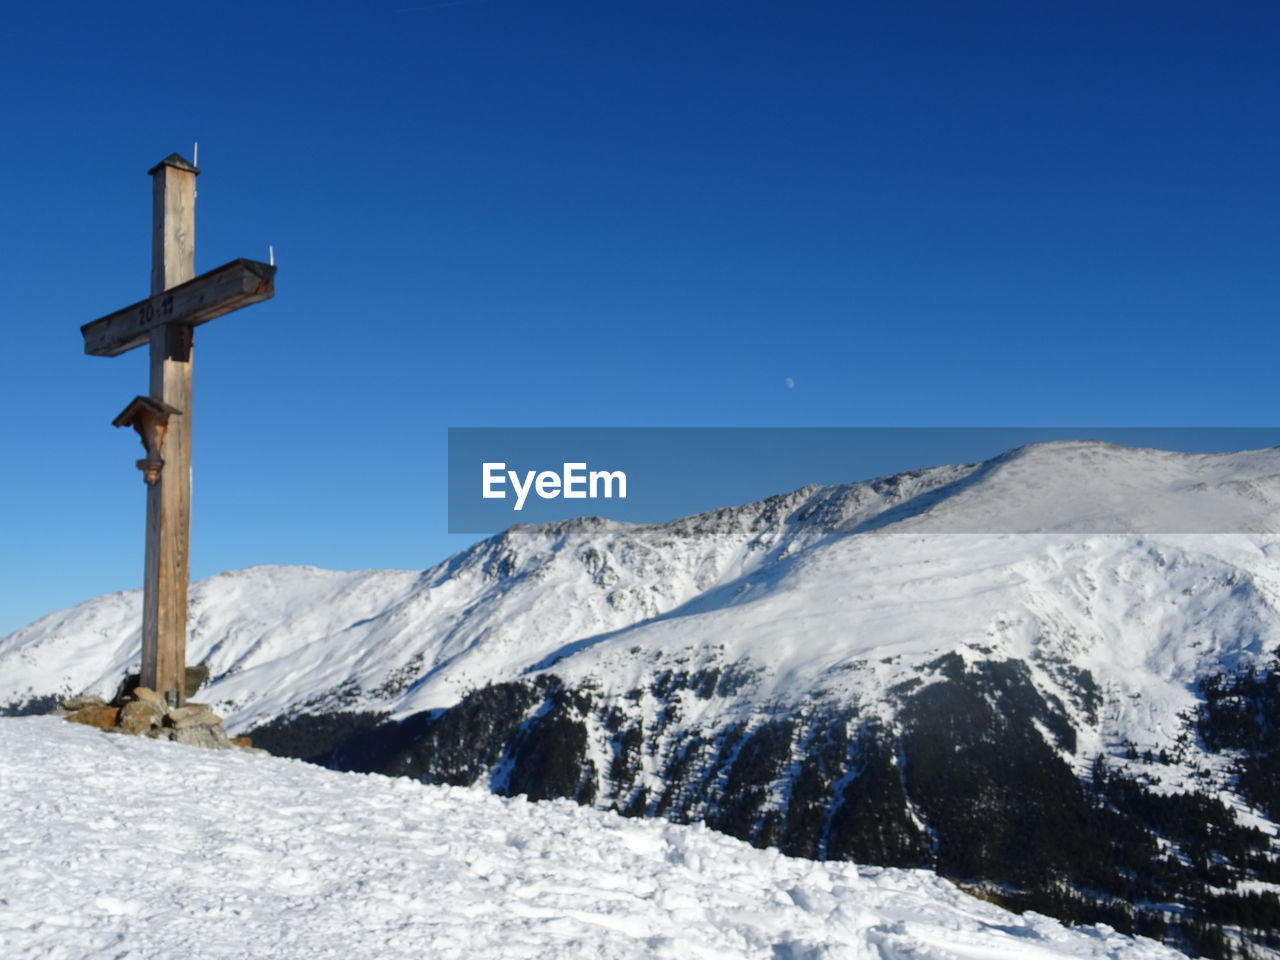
[[141, 154, 200, 704]]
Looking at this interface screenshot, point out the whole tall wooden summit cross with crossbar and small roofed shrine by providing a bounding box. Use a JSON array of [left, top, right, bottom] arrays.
[[81, 154, 275, 705]]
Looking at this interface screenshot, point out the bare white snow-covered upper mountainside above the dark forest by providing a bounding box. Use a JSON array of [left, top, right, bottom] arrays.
[[10, 443, 1280, 735]]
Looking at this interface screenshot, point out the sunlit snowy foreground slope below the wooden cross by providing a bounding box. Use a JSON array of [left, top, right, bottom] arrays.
[[0, 718, 1178, 960]]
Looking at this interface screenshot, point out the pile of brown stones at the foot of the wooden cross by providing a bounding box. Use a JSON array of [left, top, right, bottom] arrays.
[[59, 685, 266, 753]]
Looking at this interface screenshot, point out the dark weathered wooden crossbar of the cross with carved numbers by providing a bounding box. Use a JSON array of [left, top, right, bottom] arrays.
[[81, 260, 275, 357]]
